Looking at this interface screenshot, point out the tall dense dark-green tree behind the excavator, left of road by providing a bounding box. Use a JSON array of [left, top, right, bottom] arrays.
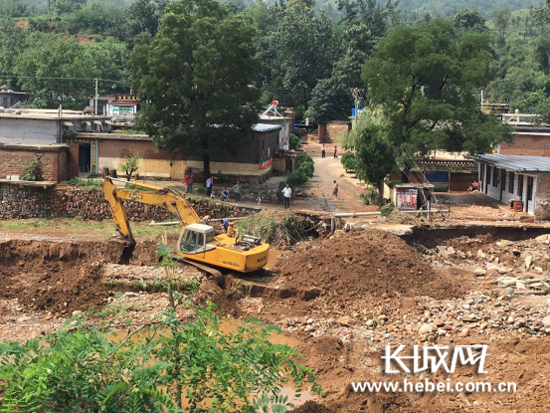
[[131, 0, 259, 183]]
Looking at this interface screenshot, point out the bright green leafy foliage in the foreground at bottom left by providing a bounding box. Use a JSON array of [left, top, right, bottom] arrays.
[[0, 237, 321, 413]]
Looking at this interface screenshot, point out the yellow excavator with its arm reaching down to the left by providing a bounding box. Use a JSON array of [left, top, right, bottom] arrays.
[[103, 176, 269, 273]]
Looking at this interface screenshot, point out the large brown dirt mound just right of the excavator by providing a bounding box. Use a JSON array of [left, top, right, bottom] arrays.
[[280, 230, 464, 303]]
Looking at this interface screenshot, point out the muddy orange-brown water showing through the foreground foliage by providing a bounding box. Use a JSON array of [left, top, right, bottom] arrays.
[[113, 316, 313, 408]]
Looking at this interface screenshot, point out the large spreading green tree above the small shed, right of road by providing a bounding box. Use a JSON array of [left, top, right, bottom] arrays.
[[363, 20, 509, 156]]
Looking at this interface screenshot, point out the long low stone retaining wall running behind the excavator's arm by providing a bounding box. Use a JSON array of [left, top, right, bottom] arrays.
[[0, 181, 255, 222]]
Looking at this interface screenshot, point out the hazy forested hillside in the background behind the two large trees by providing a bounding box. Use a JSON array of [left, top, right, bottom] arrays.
[[0, 0, 550, 121]]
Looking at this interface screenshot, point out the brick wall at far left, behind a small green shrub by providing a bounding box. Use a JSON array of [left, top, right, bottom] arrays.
[[0, 144, 68, 182]]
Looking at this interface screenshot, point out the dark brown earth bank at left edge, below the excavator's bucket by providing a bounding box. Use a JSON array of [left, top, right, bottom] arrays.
[[0, 240, 156, 314]]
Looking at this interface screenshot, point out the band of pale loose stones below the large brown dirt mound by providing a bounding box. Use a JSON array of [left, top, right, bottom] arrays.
[[272, 291, 550, 345]]
